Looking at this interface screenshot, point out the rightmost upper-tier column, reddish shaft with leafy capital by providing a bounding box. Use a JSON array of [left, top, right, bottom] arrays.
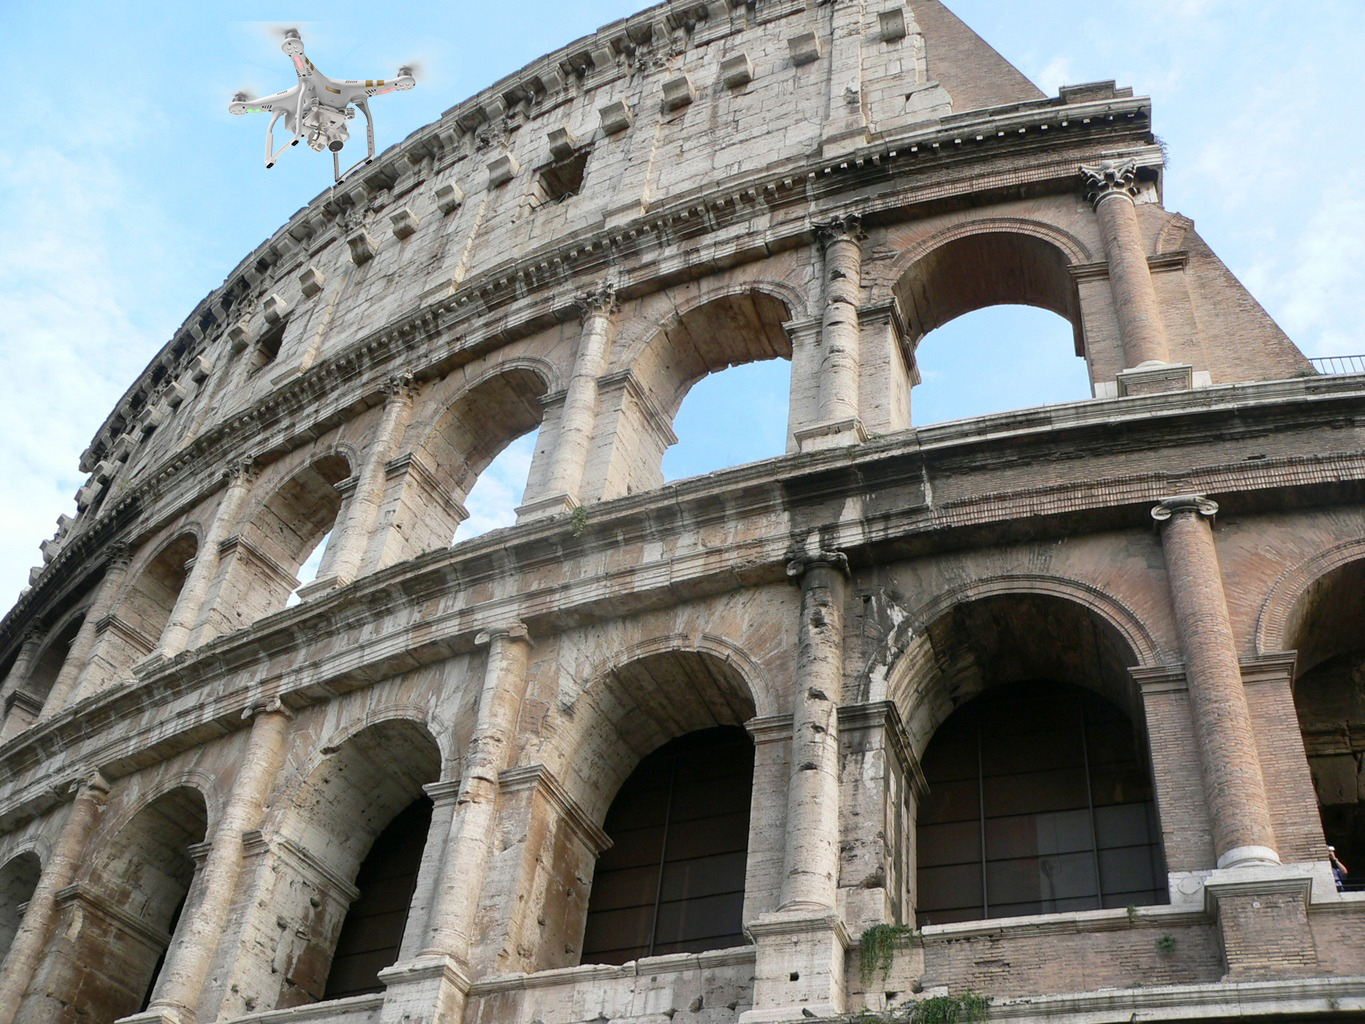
[[1081, 158, 1171, 367]]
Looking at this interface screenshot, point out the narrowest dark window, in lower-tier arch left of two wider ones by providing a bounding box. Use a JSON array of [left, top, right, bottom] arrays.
[[322, 796, 431, 999]]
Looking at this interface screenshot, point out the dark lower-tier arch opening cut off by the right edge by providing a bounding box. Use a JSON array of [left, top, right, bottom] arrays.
[[1284, 561, 1365, 890]]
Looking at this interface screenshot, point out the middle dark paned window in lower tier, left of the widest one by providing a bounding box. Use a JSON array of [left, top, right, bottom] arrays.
[[583, 728, 753, 964]]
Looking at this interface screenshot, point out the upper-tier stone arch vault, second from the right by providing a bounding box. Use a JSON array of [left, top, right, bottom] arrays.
[[597, 284, 793, 498]]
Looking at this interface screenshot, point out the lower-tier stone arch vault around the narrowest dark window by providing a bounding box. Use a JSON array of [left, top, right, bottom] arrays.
[[242, 707, 442, 1008]]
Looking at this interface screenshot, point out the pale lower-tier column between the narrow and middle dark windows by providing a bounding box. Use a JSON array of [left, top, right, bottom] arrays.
[[422, 623, 531, 961]]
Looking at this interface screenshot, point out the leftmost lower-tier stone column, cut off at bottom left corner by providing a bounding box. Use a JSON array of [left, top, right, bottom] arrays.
[[0, 771, 109, 1024]]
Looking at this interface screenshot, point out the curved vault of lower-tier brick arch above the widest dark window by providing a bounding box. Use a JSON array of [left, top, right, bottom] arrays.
[[864, 573, 1168, 751]]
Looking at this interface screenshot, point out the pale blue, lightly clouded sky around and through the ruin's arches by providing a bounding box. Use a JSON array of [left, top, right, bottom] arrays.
[[0, 0, 1365, 609]]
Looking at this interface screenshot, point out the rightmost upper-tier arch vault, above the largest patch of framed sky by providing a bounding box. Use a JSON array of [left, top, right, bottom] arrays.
[[890, 217, 1093, 376]]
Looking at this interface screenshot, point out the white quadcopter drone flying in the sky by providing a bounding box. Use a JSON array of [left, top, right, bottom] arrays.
[[228, 29, 416, 182]]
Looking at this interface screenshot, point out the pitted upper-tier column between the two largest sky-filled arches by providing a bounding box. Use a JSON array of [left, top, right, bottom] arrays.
[[797, 217, 867, 451]]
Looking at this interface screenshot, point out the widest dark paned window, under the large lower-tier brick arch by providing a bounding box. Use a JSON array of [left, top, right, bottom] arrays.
[[916, 683, 1166, 926]]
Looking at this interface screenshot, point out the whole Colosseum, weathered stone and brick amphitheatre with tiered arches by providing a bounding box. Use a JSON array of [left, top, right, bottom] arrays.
[[0, 0, 1365, 1024]]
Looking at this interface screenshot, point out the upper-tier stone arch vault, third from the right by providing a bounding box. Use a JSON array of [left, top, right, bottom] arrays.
[[404, 356, 558, 550]]
